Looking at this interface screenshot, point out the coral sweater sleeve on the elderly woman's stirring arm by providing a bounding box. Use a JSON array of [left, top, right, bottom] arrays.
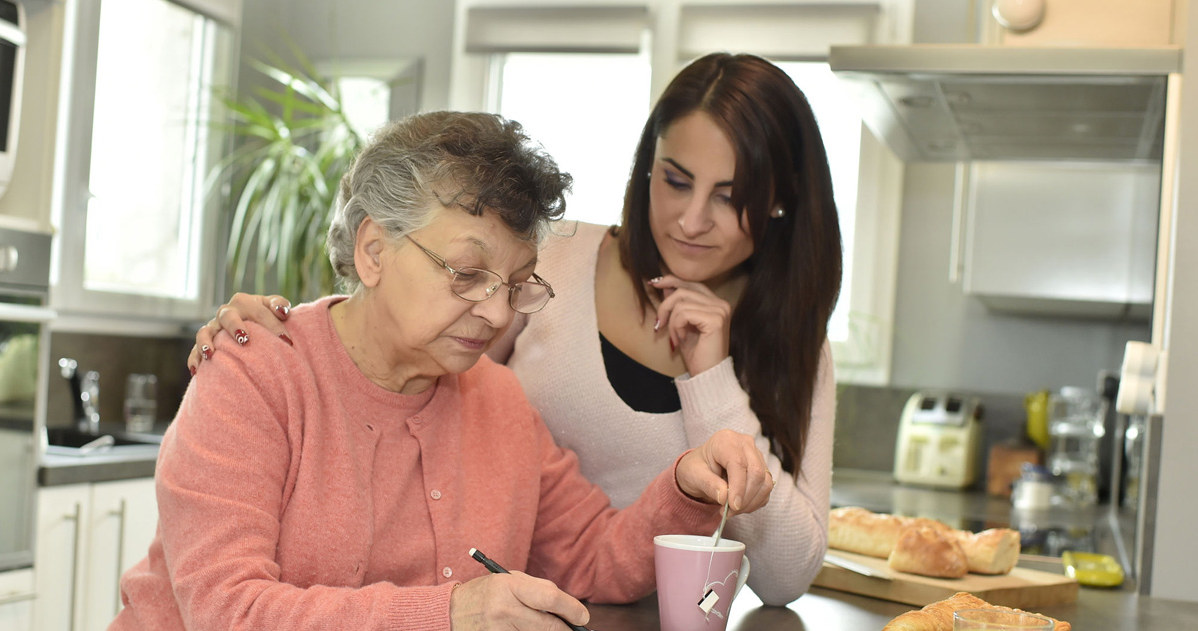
[[528, 420, 719, 603]]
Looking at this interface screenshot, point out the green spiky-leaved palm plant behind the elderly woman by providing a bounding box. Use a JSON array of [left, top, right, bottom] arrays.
[[208, 51, 363, 302]]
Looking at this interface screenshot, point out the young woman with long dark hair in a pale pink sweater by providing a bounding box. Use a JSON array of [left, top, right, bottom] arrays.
[[188, 54, 842, 605]]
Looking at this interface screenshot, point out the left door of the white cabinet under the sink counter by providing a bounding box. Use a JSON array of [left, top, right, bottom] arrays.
[[34, 484, 91, 631]]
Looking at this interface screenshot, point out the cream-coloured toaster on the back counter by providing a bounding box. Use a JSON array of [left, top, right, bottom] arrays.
[[895, 392, 981, 489]]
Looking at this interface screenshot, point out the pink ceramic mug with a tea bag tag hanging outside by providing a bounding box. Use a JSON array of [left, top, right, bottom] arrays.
[[653, 534, 749, 631]]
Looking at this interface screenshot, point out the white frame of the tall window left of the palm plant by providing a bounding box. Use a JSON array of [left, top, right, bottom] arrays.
[[52, 0, 241, 335]]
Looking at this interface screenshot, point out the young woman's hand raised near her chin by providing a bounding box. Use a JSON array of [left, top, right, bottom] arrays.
[[649, 275, 732, 375]]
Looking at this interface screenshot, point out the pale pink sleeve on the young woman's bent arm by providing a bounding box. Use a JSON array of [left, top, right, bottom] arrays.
[[676, 344, 836, 606]]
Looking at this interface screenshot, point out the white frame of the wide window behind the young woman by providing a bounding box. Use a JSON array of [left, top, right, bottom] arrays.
[[449, 0, 914, 386]]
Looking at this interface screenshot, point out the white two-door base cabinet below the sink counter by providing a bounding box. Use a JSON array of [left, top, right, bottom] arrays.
[[34, 478, 158, 631]]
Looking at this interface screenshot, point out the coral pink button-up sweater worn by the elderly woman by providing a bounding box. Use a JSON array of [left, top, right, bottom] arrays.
[[110, 298, 718, 631]]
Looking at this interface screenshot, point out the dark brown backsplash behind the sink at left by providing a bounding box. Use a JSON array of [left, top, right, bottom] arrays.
[[46, 333, 194, 426]]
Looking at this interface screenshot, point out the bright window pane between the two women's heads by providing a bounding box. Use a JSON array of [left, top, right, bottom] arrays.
[[494, 53, 649, 225]]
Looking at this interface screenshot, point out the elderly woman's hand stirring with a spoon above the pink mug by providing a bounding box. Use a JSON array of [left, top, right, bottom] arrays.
[[676, 430, 774, 512]]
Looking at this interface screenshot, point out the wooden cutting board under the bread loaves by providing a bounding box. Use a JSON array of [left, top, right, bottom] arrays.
[[813, 550, 1077, 611]]
